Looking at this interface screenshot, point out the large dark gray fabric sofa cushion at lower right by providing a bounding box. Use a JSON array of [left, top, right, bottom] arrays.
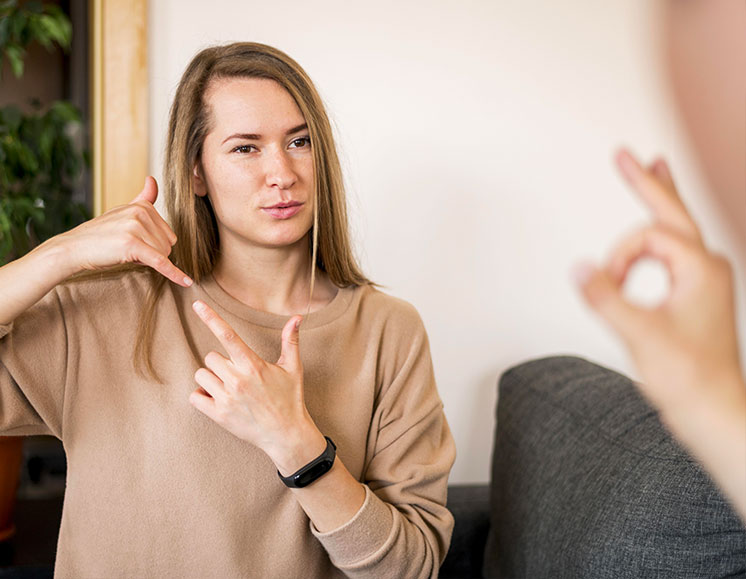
[[484, 357, 746, 579]]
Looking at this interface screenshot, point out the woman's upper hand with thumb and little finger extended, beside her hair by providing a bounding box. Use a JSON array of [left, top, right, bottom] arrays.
[[48, 177, 192, 287]]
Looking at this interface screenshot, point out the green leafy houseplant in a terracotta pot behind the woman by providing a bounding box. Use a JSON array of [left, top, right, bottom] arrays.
[[0, 0, 88, 553]]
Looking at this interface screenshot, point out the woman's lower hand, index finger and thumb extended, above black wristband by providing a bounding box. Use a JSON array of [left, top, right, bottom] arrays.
[[189, 301, 326, 475]]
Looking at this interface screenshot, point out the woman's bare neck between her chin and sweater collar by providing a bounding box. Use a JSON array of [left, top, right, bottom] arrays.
[[213, 237, 336, 315]]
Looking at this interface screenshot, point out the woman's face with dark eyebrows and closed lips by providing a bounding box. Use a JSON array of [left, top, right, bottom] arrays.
[[194, 78, 314, 248]]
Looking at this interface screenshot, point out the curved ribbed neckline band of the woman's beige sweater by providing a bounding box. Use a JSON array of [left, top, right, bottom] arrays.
[[199, 274, 356, 330]]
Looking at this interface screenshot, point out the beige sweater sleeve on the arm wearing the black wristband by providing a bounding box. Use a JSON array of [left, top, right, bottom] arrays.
[[312, 305, 456, 579]]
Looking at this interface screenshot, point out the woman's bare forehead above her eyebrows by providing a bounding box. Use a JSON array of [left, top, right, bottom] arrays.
[[205, 78, 305, 135]]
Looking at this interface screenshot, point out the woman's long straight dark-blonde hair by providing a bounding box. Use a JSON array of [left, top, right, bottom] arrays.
[[135, 42, 371, 381]]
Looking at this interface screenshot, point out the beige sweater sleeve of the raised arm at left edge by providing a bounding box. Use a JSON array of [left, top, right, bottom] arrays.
[[0, 289, 68, 438]]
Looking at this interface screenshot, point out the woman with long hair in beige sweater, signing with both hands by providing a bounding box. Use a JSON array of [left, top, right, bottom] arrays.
[[0, 43, 455, 577]]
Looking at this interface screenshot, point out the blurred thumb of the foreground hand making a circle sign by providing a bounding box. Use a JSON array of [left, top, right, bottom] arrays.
[[573, 263, 649, 345]]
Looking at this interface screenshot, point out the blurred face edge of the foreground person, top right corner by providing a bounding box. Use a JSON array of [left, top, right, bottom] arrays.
[[664, 0, 746, 241]]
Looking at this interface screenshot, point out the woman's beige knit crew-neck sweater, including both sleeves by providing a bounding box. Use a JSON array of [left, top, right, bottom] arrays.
[[0, 272, 455, 579]]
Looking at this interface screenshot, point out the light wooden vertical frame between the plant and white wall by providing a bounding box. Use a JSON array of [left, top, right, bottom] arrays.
[[89, 0, 149, 215]]
